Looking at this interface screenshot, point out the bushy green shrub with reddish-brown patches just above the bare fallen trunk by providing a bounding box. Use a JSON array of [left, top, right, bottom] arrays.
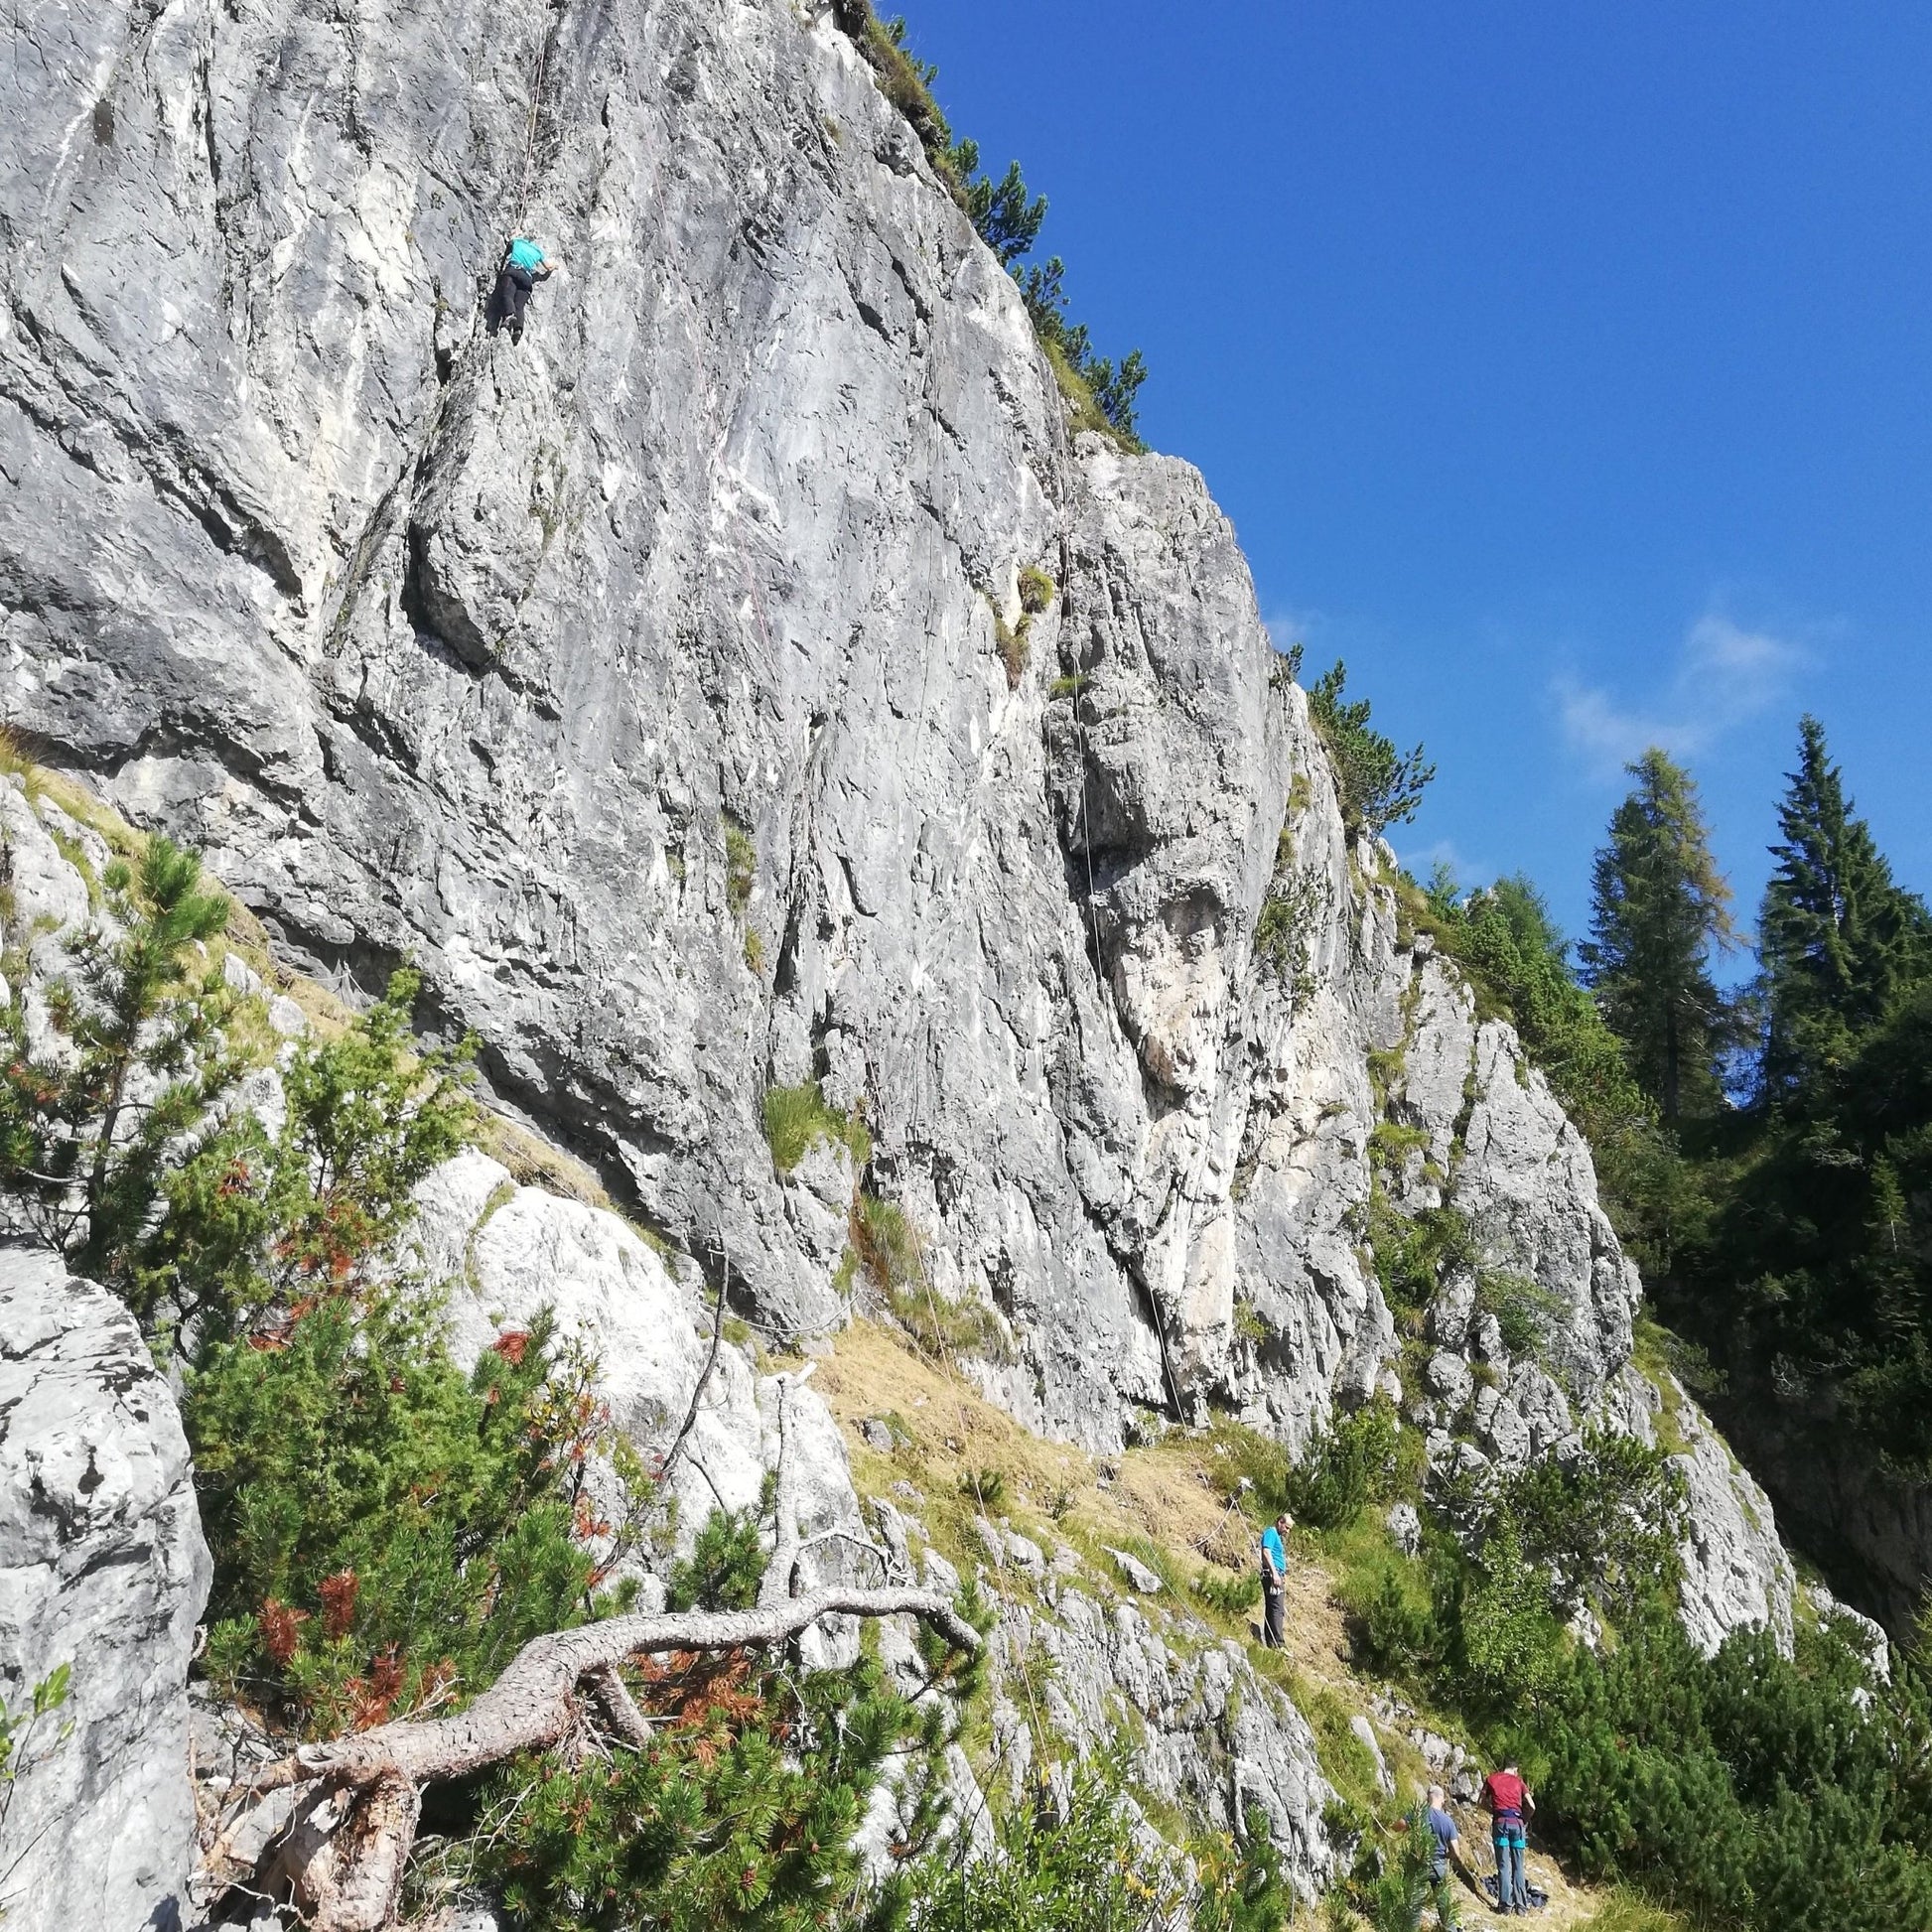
[[184, 1287, 645, 1736]]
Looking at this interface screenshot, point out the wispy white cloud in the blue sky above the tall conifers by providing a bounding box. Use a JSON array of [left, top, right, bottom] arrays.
[[1556, 613, 1807, 776]]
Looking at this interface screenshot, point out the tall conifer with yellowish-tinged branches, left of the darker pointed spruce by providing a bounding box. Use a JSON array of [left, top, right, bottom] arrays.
[[1577, 746, 1736, 1121]]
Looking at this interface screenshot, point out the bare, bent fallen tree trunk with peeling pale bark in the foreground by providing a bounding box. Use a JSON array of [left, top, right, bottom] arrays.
[[208, 1377, 980, 1932]]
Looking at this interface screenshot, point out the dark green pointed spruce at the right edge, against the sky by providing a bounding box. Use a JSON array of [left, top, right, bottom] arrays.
[[1762, 717, 1932, 1105]]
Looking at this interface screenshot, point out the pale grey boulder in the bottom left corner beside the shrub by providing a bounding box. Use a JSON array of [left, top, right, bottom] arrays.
[[0, 1248, 210, 1932]]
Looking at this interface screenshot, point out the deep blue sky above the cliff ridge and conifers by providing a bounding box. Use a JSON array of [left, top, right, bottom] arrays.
[[907, 0, 1932, 950]]
